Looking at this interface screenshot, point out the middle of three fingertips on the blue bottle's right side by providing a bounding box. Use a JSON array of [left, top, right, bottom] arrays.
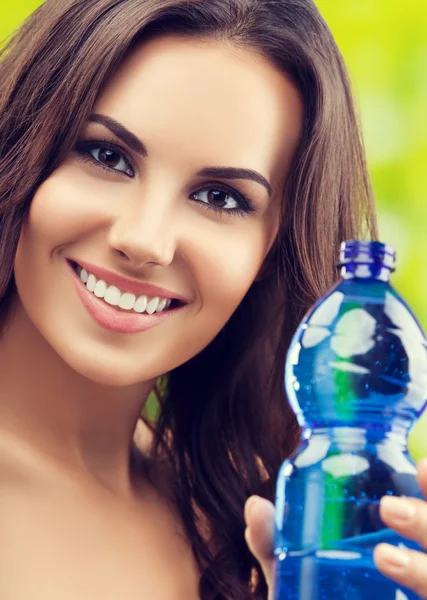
[[380, 496, 427, 548]]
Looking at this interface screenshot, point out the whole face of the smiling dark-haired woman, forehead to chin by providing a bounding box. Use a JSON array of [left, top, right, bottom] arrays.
[[15, 36, 303, 385]]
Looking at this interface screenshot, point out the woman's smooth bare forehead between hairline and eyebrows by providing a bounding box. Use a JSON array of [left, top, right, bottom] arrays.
[[96, 36, 302, 192]]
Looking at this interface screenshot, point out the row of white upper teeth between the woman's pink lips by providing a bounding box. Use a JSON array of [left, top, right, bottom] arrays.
[[77, 267, 172, 315]]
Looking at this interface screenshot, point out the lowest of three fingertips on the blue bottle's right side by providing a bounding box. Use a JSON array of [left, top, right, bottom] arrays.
[[374, 544, 427, 598]]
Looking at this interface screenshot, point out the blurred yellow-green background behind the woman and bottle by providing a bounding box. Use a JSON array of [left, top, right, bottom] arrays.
[[0, 0, 427, 458]]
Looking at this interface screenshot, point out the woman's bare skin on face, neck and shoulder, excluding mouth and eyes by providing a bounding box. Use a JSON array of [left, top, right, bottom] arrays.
[[0, 37, 303, 600]]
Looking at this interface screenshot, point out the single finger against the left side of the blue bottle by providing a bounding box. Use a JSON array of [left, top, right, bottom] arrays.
[[245, 496, 274, 588]]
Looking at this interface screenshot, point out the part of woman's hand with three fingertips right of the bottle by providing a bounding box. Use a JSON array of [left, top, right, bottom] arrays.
[[374, 460, 427, 598]]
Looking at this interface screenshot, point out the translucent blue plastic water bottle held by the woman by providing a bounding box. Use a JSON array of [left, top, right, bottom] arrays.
[[273, 241, 427, 600]]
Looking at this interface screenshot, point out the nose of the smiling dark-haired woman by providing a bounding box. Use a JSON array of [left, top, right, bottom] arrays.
[[108, 193, 176, 268]]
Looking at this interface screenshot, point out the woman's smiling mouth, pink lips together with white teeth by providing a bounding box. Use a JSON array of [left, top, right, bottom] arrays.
[[67, 260, 186, 333]]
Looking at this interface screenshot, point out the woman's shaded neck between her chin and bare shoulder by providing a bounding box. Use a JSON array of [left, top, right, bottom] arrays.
[[0, 304, 154, 491]]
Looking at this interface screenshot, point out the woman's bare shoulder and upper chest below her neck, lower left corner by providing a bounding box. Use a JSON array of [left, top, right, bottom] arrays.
[[0, 426, 200, 600]]
